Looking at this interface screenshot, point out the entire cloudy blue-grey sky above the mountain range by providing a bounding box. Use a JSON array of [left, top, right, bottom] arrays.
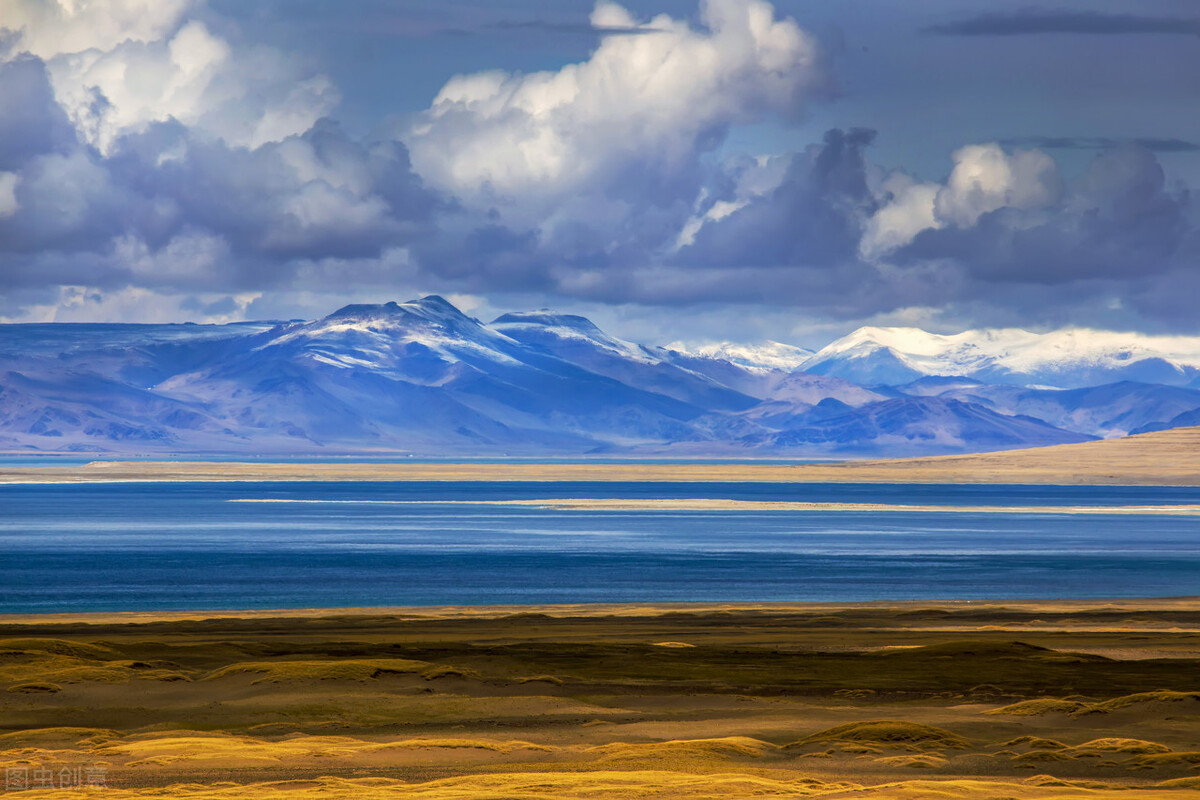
[[0, 0, 1200, 347]]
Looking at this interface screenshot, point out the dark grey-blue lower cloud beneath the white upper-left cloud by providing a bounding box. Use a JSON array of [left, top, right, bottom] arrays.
[[0, 58, 441, 297]]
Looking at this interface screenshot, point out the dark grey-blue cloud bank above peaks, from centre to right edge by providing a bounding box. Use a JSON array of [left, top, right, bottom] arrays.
[[416, 130, 1200, 327]]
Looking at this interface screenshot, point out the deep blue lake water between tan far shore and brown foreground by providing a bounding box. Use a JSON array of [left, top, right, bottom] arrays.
[[0, 482, 1200, 613]]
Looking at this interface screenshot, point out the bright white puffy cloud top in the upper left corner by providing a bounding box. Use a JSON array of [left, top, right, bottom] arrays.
[[8, 0, 338, 155]]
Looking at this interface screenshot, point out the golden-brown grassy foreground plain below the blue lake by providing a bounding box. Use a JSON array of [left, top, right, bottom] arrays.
[[0, 601, 1200, 800]]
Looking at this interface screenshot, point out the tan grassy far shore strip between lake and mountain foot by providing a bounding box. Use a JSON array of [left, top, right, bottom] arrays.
[[7, 427, 1200, 486]]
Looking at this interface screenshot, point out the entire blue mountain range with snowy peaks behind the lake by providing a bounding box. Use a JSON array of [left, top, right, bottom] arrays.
[[0, 295, 1200, 458]]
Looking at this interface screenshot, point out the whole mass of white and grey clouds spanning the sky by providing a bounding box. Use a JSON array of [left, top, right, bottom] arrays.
[[0, 0, 1200, 335]]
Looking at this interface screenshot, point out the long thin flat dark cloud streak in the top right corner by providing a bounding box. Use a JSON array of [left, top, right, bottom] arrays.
[[924, 8, 1200, 36]]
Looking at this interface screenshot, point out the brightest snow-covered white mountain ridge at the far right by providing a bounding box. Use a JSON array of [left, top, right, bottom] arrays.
[[799, 327, 1200, 389]]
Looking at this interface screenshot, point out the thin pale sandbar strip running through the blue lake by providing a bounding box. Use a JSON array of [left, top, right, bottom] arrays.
[[227, 498, 1200, 517]]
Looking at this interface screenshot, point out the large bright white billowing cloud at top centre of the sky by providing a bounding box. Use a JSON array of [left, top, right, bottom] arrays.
[[408, 0, 821, 210]]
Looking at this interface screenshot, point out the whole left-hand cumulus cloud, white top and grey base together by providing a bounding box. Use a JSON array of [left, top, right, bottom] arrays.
[[0, 0, 443, 319]]
